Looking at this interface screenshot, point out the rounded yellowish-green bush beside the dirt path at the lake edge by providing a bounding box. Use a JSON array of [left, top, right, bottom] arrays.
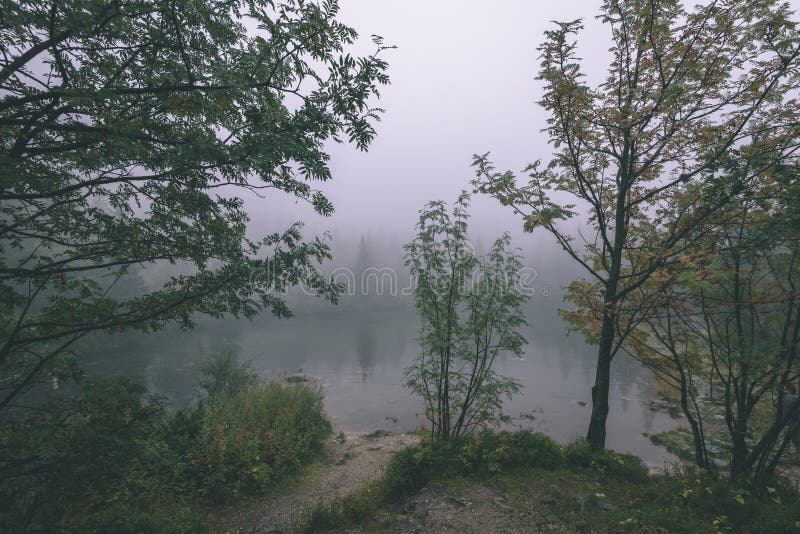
[[162, 352, 332, 503]]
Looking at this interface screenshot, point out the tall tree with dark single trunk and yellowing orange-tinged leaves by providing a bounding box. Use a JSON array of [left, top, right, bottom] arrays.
[[474, 0, 800, 449]]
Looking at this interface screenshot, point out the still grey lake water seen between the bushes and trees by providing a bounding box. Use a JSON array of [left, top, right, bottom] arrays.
[[76, 299, 674, 464]]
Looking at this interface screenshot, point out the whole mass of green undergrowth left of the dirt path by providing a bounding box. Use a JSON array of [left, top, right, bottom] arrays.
[[0, 354, 331, 533]]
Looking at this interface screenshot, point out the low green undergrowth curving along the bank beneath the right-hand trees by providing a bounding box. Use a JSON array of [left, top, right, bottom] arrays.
[[302, 432, 800, 533]]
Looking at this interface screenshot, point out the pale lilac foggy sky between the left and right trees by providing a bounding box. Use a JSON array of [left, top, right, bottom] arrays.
[[252, 0, 800, 248]]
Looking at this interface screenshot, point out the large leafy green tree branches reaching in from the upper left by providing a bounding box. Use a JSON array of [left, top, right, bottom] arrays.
[[0, 0, 388, 409]]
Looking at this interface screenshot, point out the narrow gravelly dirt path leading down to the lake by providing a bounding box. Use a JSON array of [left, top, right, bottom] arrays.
[[214, 431, 419, 534]]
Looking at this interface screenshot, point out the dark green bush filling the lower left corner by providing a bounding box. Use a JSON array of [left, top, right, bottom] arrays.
[[0, 379, 204, 532]]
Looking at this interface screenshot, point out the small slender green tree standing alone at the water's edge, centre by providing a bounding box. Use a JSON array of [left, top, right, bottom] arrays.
[[405, 193, 526, 439]]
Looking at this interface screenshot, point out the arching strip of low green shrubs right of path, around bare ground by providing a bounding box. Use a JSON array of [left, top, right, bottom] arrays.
[[300, 431, 800, 533]]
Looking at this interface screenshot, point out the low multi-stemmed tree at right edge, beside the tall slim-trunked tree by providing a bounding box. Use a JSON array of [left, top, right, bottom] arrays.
[[627, 165, 800, 478]]
